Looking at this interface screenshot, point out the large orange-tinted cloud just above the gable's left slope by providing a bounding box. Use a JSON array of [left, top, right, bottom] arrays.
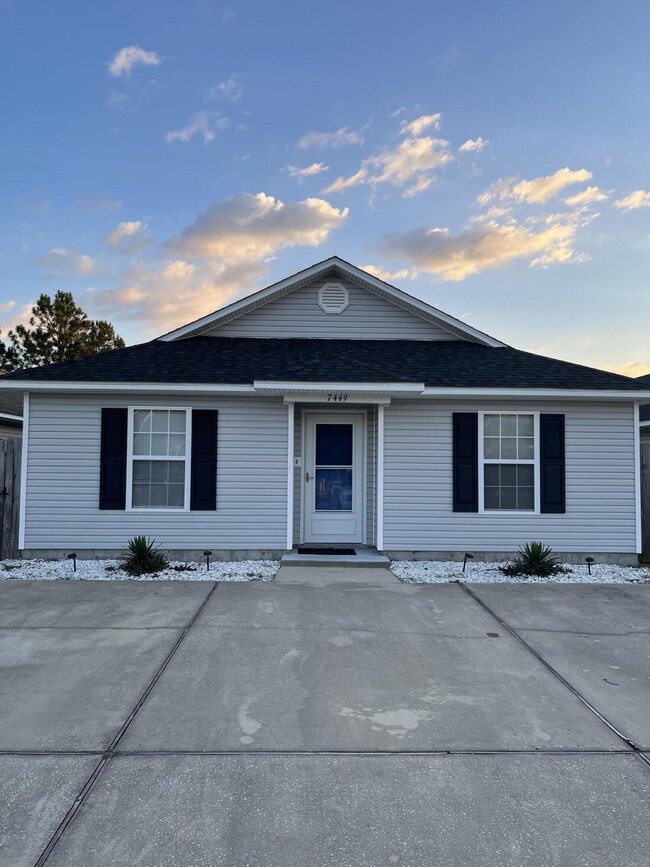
[[166, 193, 348, 262]]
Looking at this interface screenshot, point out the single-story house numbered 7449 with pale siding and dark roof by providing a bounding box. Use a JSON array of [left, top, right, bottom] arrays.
[[3, 257, 650, 562]]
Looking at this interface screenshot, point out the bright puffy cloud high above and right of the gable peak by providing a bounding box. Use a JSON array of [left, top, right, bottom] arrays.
[[324, 114, 454, 198]]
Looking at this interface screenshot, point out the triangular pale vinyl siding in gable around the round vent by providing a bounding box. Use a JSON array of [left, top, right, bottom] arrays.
[[206, 278, 460, 340]]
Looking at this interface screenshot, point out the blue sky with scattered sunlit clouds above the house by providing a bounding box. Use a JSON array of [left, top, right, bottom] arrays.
[[0, 0, 650, 375]]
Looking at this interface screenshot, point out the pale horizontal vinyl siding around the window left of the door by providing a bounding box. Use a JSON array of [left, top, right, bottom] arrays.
[[25, 394, 287, 550]]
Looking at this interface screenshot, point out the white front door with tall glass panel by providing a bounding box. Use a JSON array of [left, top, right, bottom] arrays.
[[302, 412, 365, 543]]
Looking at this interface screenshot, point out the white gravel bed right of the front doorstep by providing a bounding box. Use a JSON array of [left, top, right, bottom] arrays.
[[390, 560, 650, 584]]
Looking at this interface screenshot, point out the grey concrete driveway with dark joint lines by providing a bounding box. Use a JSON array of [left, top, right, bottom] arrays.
[[0, 568, 650, 867]]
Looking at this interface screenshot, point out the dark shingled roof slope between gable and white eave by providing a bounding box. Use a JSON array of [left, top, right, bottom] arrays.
[[7, 336, 650, 391]]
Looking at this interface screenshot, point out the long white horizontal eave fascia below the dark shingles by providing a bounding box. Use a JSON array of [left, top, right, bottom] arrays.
[[3, 380, 650, 401]]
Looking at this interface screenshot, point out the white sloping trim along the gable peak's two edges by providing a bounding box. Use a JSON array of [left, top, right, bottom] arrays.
[[158, 256, 506, 348]]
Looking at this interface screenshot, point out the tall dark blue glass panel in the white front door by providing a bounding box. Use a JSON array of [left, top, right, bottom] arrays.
[[314, 424, 353, 512]]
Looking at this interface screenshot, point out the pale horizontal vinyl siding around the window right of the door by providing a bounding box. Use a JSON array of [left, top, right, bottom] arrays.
[[384, 400, 637, 553]]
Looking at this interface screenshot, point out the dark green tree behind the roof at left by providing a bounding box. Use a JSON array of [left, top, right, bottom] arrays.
[[0, 292, 124, 373]]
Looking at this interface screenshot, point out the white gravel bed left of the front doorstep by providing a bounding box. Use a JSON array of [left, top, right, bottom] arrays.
[[0, 559, 280, 581]]
